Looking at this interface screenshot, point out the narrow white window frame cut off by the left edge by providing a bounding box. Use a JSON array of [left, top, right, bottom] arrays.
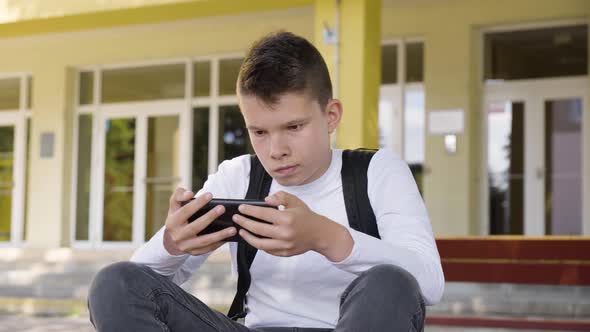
[[0, 72, 32, 248]]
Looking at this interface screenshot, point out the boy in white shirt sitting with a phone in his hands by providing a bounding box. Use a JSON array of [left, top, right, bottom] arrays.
[[89, 32, 444, 332]]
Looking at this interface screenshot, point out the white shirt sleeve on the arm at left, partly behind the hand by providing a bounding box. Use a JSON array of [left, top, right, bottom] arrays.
[[131, 155, 250, 285]]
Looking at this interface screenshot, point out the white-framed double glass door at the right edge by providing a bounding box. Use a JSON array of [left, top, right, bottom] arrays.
[[482, 79, 590, 235]]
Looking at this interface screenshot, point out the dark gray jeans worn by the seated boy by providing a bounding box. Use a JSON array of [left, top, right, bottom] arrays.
[[88, 262, 425, 332]]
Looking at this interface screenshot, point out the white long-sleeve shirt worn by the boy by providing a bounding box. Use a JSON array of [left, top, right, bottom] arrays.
[[131, 150, 444, 328]]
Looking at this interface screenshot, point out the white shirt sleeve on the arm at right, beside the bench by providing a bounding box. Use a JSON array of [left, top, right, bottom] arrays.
[[334, 150, 445, 305]]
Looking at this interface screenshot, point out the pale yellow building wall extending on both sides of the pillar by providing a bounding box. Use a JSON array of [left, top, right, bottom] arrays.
[[0, 0, 590, 247]]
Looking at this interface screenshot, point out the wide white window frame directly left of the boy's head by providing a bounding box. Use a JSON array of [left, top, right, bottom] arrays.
[[69, 52, 244, 249]]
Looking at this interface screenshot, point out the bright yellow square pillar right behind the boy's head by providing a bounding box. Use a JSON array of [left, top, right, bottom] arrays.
[[314, 0, 381, 148]]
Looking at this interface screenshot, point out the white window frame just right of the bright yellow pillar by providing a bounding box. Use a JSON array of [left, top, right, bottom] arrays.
[[379, 37, 426, 160]]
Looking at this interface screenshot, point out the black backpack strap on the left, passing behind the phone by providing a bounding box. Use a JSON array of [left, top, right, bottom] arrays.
[[227, 155, 272, 320]]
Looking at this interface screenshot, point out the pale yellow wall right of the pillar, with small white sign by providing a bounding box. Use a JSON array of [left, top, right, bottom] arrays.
[[382, 0, 590, 235]]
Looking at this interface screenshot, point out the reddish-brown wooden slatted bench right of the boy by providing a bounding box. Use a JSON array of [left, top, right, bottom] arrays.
[[426, 236, 590, 331]]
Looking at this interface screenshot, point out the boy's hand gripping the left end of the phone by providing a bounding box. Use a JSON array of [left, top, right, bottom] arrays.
[[164, 188, 236, 255]]
